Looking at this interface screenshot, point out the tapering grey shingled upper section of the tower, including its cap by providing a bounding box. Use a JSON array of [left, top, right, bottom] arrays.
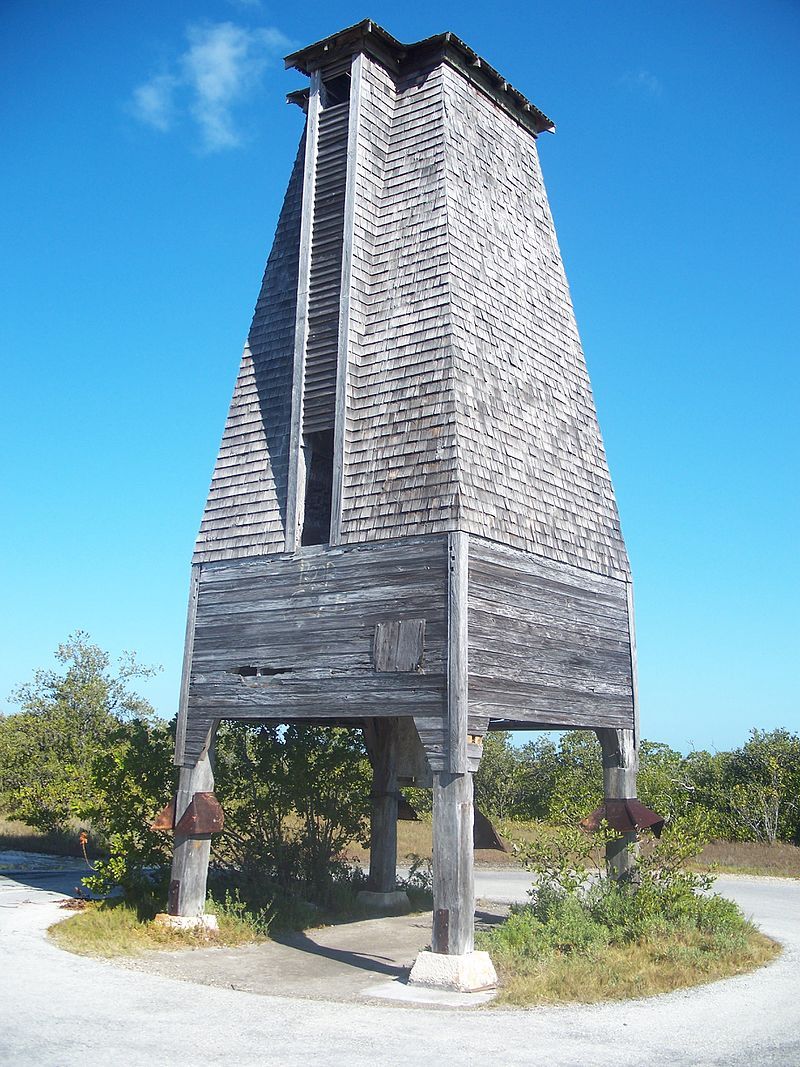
[[195, 29, 629, 578]]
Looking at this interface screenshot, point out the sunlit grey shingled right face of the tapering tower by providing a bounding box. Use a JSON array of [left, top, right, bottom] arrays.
[[443, 66, 628, 576]]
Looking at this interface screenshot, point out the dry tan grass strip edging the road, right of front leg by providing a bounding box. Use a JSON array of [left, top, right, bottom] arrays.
[[494, 929, 781, 1007]]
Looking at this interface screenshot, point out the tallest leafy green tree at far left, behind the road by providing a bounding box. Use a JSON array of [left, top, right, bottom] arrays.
[[0, 631, 158, 831]]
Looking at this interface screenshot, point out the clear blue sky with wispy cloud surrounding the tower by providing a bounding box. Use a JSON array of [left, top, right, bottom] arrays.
[[0, 0, 800, 749]]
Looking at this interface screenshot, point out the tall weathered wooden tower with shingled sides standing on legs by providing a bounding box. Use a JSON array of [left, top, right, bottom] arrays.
[[170, 21, 637, 989]]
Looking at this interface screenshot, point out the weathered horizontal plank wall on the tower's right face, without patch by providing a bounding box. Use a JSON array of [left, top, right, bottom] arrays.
[[469, 537, 634, 729]]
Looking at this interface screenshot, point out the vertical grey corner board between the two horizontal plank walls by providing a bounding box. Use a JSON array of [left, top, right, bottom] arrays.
[[447, 534, 469, 775]]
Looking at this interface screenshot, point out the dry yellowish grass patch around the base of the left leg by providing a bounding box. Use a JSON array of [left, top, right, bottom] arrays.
[[48, 902, 265, 958]]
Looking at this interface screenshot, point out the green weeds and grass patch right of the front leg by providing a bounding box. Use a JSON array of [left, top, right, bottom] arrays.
[[477, 883, 781, 1006]]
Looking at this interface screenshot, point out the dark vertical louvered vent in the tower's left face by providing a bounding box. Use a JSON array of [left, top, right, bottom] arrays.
[[303, 99, 349, 434]]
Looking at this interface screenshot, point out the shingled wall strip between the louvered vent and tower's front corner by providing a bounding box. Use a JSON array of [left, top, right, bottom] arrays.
[[341, 57, 458, 543]]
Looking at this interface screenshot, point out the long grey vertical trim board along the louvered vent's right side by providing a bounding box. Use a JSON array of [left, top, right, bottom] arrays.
[[331, 54, 364, 544]]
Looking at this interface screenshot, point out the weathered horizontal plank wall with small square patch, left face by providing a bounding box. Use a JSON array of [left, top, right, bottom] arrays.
[[186, 538, 454, 760]]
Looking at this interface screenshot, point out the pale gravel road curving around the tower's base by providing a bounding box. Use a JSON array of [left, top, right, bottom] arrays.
[[0, 872, 800, 1067]]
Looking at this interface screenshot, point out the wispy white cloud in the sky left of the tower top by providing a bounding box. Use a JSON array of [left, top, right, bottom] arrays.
[[131, 22, 291, 152]]
